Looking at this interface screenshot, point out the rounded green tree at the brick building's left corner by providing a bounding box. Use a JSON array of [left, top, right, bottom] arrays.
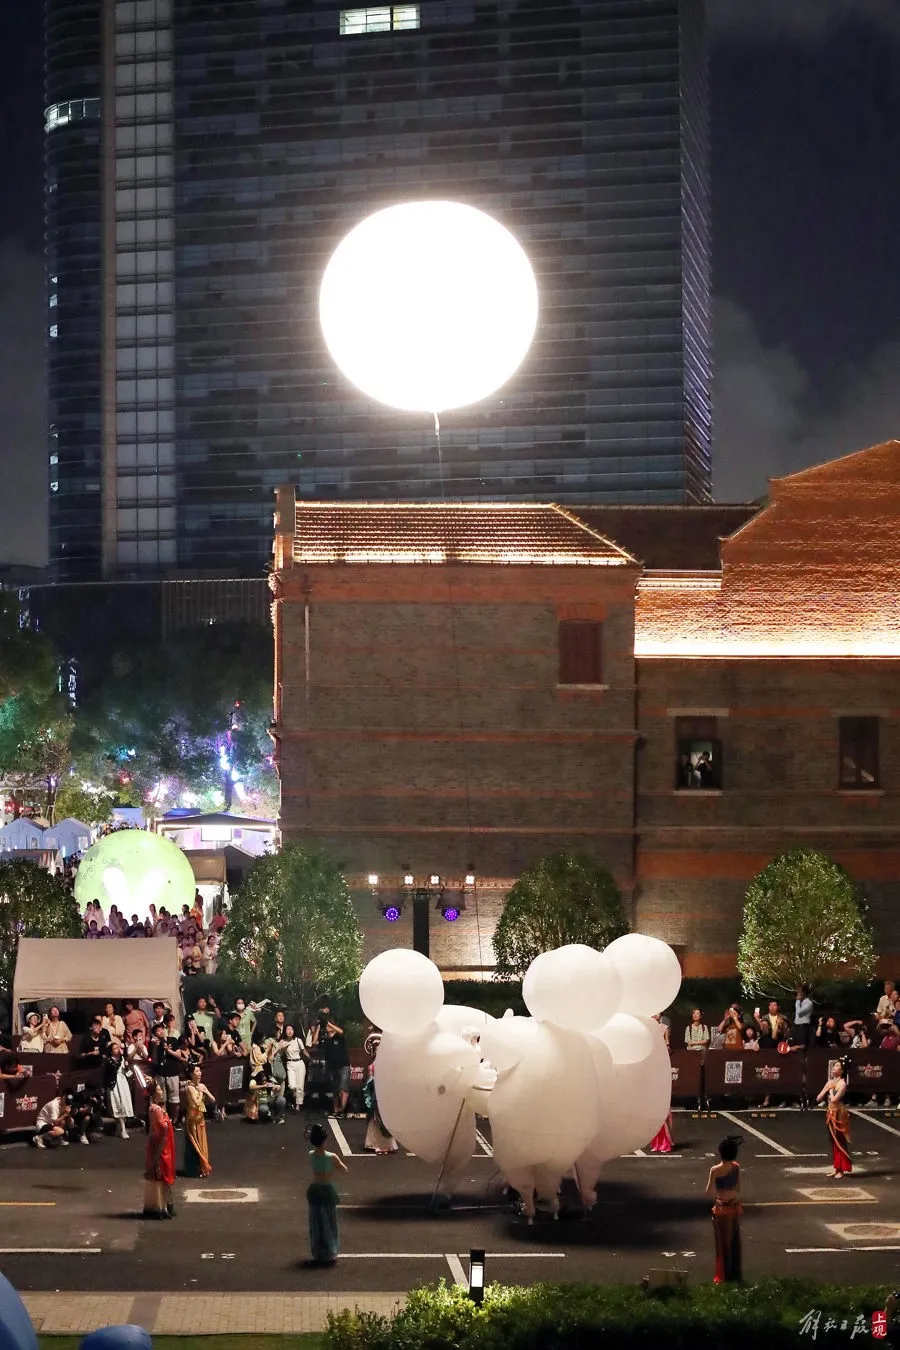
[[219, 844, 363, 1007]]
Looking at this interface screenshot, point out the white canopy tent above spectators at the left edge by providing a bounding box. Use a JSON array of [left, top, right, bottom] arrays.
[[12, 937, 181, 1033]]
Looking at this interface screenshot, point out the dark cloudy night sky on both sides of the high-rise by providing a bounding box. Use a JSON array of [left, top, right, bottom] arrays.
[[0, 0, 900, 562]]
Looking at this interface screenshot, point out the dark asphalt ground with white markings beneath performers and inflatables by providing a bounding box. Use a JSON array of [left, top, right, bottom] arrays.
[[0, 1110, 900, 1331]]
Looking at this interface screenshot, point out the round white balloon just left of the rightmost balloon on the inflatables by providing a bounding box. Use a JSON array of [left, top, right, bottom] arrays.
[[522, 942, 622, 1031]]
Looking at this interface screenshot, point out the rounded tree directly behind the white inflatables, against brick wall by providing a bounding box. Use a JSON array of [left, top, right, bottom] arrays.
[[494, 851, 627, 980]]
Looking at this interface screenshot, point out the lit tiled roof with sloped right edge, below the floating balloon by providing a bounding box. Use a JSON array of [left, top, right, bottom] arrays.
[[293, 501, 634, 567]]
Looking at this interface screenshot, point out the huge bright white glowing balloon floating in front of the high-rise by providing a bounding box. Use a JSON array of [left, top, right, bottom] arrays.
[[318, 201, 537, 413]]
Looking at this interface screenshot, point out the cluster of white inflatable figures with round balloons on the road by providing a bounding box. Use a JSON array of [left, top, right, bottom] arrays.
[[359, 933, 681, 1218]]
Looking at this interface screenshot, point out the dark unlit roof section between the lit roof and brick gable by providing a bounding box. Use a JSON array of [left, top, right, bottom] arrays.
[[572, 502, 761, 571]]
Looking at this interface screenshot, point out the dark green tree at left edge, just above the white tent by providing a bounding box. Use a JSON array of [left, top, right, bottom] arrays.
[[0, 859, 81, 1000]]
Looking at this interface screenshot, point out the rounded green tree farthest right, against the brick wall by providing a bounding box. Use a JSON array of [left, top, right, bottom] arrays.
[[738, 849, 876, 994]]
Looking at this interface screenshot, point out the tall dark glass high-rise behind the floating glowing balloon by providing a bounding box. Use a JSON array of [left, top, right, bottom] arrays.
[[46, 0, 710, 581]]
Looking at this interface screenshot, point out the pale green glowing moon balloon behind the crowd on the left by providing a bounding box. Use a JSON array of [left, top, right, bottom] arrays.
[[76, 830, 197, 919]]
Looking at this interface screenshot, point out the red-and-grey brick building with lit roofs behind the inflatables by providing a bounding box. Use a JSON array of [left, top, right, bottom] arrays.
[[271, 441, 900, 975]]
